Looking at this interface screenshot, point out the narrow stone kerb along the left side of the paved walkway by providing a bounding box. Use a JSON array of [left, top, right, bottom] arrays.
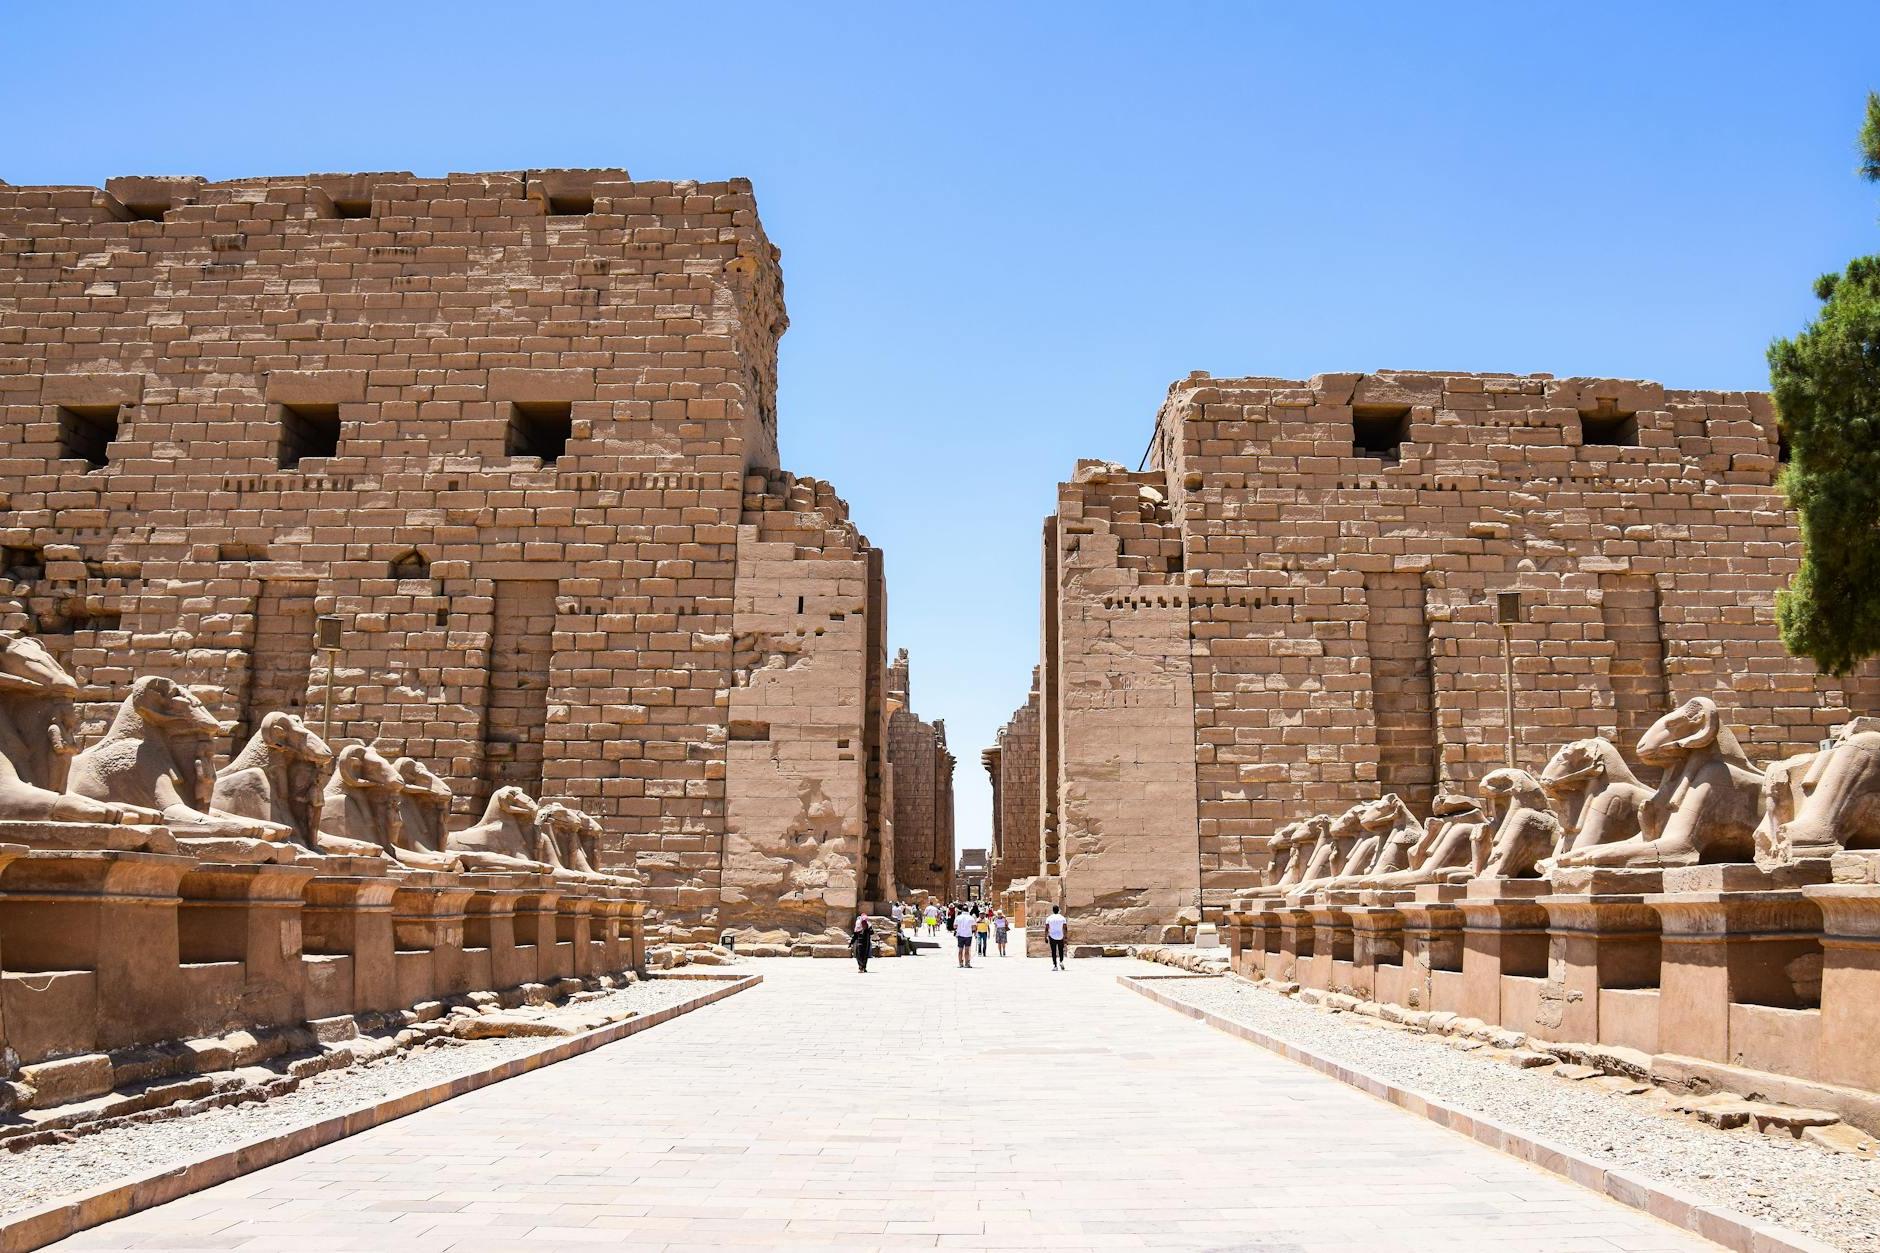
[[0, 975, 763, 1253]]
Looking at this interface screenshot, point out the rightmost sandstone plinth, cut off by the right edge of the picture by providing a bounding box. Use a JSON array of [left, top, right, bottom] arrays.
[[1801, 884, 1880, 1091]]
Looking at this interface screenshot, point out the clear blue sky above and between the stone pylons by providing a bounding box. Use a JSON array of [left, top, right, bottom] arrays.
[[0, 0, 1880, 845]]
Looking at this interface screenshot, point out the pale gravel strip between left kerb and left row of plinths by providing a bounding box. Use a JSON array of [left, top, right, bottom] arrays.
[[0, 971, 731, 1215]]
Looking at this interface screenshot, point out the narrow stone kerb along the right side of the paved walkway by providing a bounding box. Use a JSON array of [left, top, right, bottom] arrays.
[[1117, 975, 1837, 1253]]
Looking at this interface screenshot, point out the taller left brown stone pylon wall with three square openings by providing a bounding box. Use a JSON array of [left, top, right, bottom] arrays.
[[0, 169, 891, 931]]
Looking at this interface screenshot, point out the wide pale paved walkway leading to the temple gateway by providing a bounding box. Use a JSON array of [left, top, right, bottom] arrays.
[[58, 944, 1713, 1253]]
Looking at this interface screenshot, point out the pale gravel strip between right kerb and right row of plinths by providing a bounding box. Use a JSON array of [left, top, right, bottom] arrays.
[[1151, 976, 1880, 1253]]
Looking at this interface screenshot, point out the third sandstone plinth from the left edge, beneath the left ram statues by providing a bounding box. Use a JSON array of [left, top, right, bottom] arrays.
[[301, 858, 406, 1018]]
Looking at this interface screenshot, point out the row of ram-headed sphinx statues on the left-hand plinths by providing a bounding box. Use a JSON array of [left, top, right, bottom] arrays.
[[0, 632, 631, 882]]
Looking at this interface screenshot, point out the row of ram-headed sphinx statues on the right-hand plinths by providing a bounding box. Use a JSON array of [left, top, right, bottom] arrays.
[[1265, 696, 1880, 896]]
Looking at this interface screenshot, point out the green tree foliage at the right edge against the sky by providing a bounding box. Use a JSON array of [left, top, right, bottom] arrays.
[[1769, 92, 1880, 674]]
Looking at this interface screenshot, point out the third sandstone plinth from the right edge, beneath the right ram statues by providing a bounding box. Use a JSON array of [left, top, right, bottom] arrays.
[[1534, 867, 1664, 1054]]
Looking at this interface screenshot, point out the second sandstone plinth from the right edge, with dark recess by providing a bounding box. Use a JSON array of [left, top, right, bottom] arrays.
[[1647, 860, 1829, 1078]]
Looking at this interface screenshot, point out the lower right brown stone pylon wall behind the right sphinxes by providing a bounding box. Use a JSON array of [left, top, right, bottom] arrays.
[[1006, 373, 1874, 941]]
